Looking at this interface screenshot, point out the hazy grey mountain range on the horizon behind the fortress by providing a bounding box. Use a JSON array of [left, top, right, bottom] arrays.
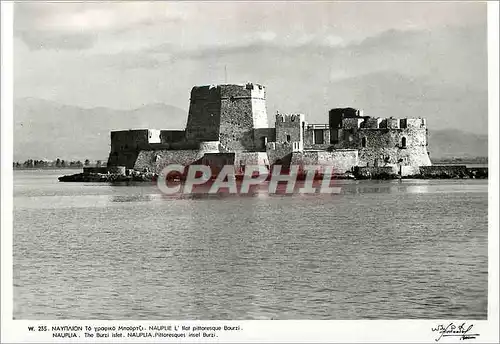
[[14, 98, 488, 161]]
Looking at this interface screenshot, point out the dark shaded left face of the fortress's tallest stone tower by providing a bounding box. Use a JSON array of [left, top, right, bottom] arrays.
[[186, 86, 221, 141]]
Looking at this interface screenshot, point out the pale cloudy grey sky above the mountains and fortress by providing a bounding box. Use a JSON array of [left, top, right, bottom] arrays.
[[14, 1, 487, 134]]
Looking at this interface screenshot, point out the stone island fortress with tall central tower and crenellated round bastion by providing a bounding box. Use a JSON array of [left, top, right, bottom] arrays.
[[104, 83, 431, 175]]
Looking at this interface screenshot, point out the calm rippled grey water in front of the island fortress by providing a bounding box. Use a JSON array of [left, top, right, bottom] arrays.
[[14, 171, 488, 320]]
